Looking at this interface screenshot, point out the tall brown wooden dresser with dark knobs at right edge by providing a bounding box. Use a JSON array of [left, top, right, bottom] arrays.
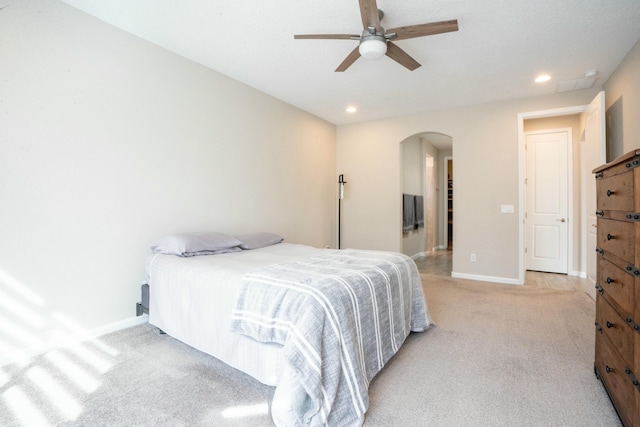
[[593, 150, 640, 426]]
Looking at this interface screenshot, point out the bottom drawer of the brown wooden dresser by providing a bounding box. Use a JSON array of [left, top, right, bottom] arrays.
[[595, 332, 637, 426]]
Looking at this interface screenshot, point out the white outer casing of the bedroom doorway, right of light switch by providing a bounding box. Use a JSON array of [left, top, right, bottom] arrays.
[[518, 105, 588, 285]]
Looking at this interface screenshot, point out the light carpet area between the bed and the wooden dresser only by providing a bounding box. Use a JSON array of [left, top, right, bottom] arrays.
[[367, 275, 620, 426]]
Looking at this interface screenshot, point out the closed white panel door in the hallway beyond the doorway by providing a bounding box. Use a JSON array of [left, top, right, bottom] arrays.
[[525, 130, 570, 274]]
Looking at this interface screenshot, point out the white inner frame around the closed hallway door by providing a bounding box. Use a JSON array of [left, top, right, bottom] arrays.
[[524, 127, 575, 276]]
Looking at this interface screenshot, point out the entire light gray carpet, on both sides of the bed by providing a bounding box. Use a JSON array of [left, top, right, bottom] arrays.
[[0, 275, 620, 426]]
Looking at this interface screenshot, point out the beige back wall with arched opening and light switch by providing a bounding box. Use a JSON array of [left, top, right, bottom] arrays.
[[337, 89, 597, 281]]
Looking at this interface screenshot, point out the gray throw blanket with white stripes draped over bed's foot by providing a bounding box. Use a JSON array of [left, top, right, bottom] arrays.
[[232, 250, 432, 426]]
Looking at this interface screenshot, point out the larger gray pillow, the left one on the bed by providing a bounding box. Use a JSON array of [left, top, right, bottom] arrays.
[[151, 232, 242, 256]]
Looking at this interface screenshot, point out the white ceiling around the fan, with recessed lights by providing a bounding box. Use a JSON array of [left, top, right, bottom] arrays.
[[63, 0, 640, 125]]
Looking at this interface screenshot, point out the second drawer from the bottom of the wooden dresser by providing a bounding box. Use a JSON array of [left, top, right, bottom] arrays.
[[596, 295, 635, 365]]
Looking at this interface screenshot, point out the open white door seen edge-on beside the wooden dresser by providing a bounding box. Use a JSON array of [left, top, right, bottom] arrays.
[[582, 92, 606, 299]]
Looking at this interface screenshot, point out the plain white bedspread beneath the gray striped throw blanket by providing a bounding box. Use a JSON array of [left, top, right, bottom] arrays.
[[146, 243, 324, 386]]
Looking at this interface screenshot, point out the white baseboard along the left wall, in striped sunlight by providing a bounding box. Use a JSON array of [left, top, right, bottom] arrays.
[[0, 314, 149, 368]]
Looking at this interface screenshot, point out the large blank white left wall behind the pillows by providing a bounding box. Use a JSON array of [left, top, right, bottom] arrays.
[[0, 0, 337, 365]]
